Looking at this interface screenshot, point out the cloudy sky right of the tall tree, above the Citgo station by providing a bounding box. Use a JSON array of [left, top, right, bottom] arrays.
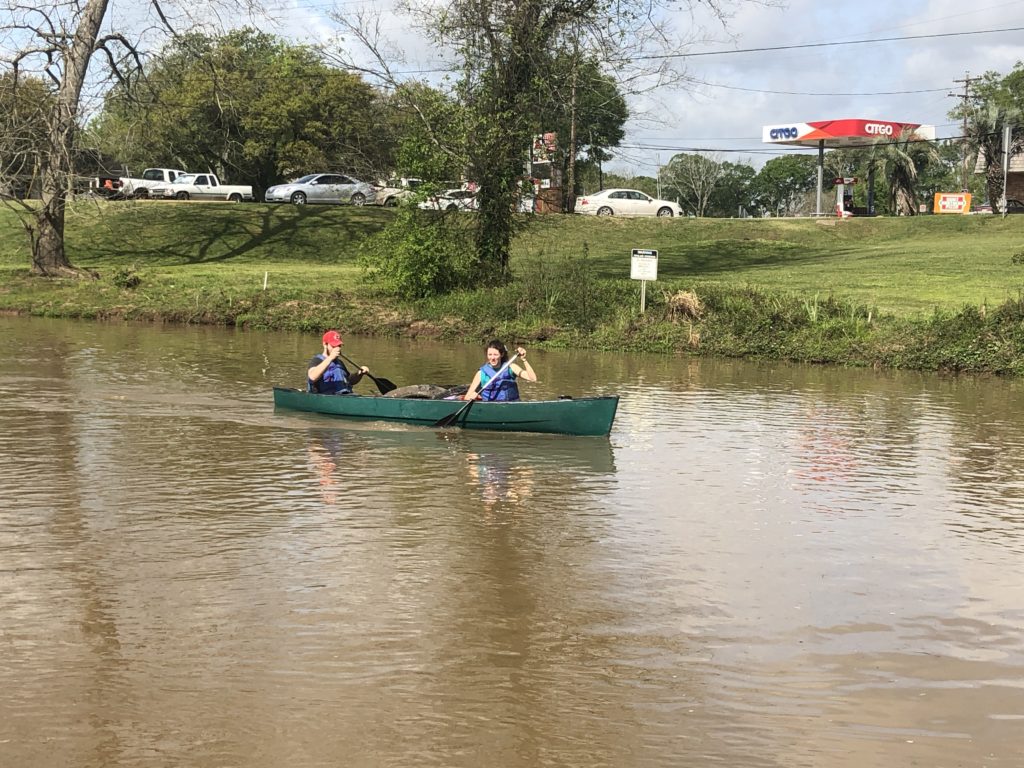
[[621, 0, 1024, 174]]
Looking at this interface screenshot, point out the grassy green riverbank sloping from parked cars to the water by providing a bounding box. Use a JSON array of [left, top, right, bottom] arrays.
[[0, 202, 1024, 374]]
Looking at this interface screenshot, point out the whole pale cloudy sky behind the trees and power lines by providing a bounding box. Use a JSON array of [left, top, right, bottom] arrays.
[[199, 0, 1024, 175]]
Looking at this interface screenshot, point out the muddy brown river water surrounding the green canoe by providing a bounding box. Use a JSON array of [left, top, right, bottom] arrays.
[[0, 318, 1024, 768]]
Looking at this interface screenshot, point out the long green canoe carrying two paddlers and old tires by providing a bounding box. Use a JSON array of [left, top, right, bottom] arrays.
[[273, 387, 618, 435]]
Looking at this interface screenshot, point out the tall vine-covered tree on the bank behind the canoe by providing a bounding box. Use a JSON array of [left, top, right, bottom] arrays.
[[334, 0, 749, 283]]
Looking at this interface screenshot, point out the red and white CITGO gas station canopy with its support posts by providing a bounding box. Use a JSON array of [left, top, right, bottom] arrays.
[[761, 118, 935, 216]]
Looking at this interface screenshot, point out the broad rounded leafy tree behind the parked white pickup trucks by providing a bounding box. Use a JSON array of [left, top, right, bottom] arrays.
[[94, 29, 394, 188]]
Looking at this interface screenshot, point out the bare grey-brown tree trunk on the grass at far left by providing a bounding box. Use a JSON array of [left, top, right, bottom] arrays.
[[32, 0, 110, 275]]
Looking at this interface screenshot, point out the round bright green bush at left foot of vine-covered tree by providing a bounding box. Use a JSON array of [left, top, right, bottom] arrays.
[[359, 206, 479, 299]]
